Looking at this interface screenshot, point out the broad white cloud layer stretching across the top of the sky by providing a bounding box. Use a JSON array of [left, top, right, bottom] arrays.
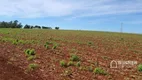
[[0, 0, 142, 19]]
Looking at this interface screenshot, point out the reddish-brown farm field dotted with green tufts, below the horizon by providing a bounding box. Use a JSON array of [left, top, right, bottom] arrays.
[[0, 29, 142, 80]]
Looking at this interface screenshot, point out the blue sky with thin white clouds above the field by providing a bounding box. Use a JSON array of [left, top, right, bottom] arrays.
[[0, 0, 142, 33]]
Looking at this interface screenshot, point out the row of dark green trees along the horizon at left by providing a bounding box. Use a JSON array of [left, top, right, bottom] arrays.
[[0, 20, 59, 30]]
